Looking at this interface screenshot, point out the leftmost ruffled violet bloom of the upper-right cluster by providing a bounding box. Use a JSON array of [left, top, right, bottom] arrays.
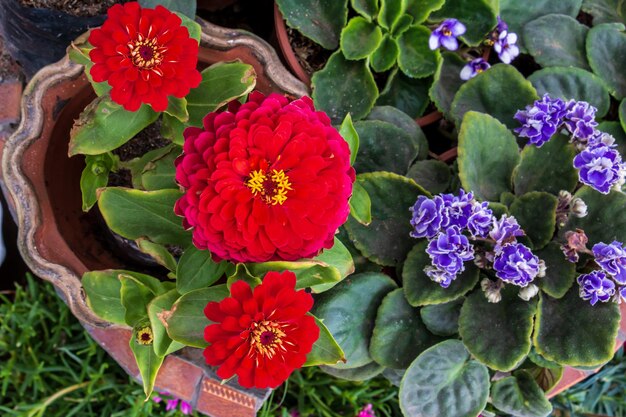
[[514, 94, 567, 148]]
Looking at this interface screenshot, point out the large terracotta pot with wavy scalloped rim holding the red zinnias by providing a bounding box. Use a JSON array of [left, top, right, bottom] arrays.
[[2, 17, 307, 417]]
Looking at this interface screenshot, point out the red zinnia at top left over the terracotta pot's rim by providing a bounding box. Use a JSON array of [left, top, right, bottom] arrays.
[[89, 2, 202, 111]]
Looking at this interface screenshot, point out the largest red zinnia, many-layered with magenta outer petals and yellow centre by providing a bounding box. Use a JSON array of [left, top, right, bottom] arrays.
[[175, 92, 354, 262]]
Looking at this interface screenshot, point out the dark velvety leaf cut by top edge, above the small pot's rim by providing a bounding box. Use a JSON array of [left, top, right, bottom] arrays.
[[276, 0, 348, 49]]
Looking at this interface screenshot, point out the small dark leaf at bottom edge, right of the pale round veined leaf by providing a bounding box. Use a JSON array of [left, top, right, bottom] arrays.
[[491, 371, 552, 417]]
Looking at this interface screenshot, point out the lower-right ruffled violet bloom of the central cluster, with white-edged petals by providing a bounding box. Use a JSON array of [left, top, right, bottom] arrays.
[[493, 243, 539, 287]]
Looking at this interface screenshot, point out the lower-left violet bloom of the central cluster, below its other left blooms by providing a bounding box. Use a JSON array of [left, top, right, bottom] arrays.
[[426, 226, 474, 275]]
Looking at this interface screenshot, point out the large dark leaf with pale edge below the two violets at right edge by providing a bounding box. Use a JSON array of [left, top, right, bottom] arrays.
[[533, 286, 620, 367]]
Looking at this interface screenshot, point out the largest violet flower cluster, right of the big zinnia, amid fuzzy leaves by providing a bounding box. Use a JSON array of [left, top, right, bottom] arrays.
[[411, 190, 545, 288]]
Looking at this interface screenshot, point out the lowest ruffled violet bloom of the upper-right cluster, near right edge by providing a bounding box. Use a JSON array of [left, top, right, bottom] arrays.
[[574, 143, 624, 194]]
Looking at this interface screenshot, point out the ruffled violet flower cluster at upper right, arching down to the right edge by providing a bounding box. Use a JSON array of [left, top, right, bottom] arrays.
[[515, 94, 626, 194]]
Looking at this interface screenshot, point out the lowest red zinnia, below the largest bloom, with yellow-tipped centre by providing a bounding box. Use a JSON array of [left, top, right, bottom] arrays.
[[204, 271, 319, 388]]
